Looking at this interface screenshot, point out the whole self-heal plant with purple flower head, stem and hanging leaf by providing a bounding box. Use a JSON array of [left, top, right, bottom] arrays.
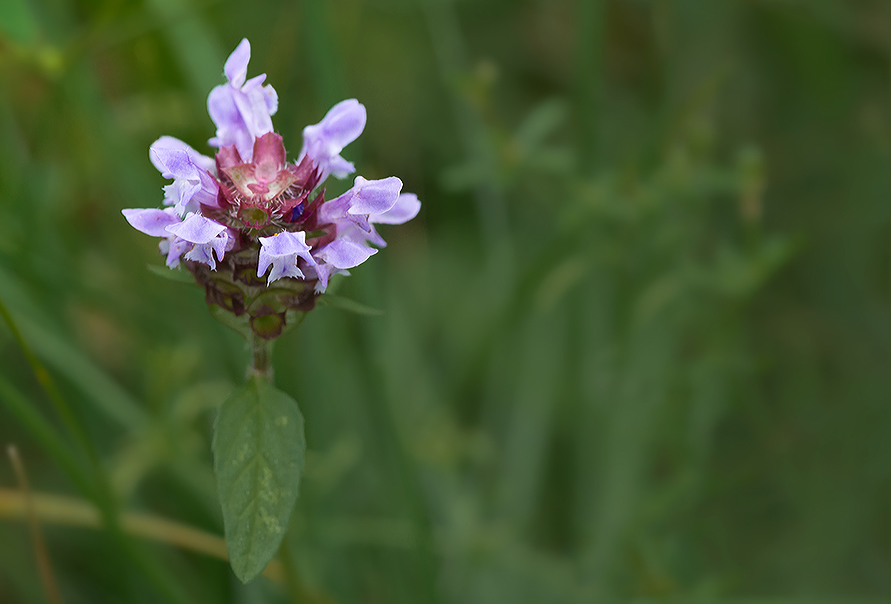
[[122, 40, 421, 582]]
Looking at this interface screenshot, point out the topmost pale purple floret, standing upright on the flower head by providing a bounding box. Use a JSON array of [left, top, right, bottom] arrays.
[[207, 39, 278, 161]]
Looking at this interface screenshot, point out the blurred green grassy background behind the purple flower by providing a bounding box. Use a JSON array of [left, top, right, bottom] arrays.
[[0, 0, 891, 604]]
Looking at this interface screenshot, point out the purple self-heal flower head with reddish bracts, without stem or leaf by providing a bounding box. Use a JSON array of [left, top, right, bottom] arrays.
[[123, 40, 421, 339]]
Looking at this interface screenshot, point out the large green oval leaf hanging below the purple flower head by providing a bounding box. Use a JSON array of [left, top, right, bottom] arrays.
[[213, 377, 306, 583]]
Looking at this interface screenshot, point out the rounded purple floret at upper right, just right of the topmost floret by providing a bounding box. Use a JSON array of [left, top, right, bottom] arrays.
[[300, 99, 366, 180]]
